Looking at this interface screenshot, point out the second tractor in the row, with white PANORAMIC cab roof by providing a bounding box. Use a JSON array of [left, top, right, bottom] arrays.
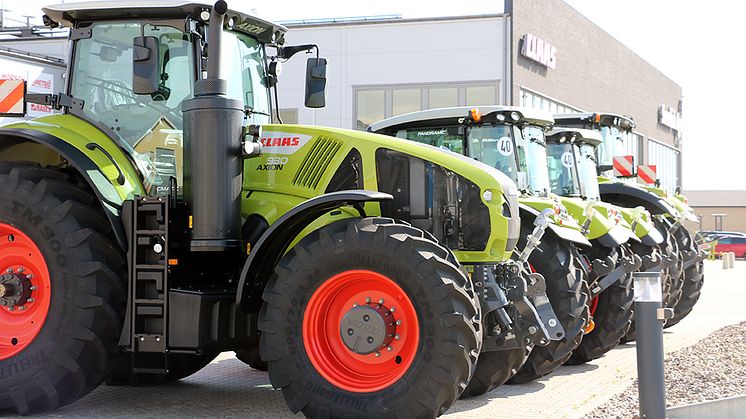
[[370, 106, 600, 392]]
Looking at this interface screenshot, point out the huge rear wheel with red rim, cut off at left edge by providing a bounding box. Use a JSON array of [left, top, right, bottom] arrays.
[[0, 162, 126, 414]]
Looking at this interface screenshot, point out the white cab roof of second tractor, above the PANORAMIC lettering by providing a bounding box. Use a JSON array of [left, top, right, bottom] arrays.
[[368, 106, 554, 132]]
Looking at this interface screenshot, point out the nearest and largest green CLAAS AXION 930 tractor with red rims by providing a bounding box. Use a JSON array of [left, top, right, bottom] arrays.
[[0, 1, 564, 417]]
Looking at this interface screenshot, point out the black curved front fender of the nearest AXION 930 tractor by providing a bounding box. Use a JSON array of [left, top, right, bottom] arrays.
[[236, 190, 393, 310]]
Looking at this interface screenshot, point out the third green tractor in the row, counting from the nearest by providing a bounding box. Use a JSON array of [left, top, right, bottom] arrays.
[[547, 128, 674, 348]]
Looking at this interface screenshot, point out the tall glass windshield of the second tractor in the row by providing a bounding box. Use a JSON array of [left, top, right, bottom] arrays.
[[514, 125, 550, 196]]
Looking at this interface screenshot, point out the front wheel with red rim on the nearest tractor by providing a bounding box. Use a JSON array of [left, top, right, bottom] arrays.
[[259, 218, 481, 418]]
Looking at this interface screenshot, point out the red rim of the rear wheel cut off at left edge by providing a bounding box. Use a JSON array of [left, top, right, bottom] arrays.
[[0, 223, 51, 360]]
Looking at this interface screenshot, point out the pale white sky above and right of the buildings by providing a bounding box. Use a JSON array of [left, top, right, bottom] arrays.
[[1, 0, 746, 193]]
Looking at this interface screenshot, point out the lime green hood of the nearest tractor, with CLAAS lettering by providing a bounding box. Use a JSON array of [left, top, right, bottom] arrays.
[[243, 124, 520, 262]]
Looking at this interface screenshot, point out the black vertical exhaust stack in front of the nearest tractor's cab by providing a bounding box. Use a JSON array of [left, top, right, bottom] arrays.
[[181, 0, 244, 252]]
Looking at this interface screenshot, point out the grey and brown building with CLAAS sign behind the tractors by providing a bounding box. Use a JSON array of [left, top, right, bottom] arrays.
[[279, 0, 682, 191]]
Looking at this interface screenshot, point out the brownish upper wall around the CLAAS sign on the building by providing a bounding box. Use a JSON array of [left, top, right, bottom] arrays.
[[511, 0, 681, 154]]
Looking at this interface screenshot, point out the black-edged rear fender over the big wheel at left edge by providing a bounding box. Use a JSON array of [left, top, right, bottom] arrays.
[[0, 128, 127, 249]]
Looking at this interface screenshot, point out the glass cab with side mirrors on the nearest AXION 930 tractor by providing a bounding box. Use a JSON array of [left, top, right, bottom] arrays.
[[32, 0, 325, 194]]
